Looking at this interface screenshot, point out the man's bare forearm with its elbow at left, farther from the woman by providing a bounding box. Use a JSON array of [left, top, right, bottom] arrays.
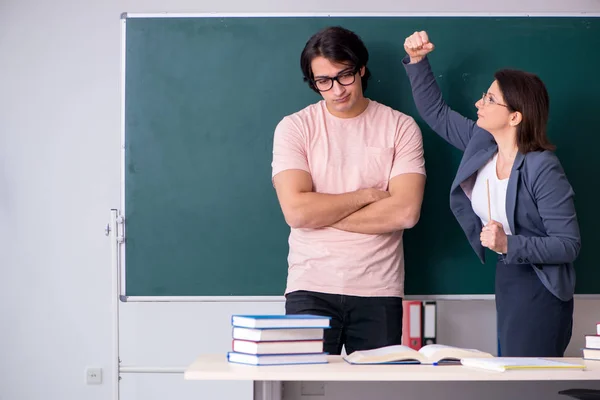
[[286, 189, 381, 229]]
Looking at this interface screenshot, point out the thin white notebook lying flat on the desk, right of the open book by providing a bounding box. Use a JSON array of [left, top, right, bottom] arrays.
[[460, 357, 585, 372]]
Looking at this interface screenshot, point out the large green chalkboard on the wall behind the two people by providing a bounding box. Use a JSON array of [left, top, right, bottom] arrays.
[[124, 16, 600, 296]]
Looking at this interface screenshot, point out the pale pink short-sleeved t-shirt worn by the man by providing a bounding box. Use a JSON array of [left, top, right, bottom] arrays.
[[272, 100, 425, 297]]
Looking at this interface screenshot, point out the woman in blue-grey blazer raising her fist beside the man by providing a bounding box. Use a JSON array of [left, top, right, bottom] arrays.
[[403, 32, 580, 357]]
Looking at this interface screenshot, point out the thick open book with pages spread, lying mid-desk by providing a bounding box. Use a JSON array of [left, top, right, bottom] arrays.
[[344, 344, 494, 365]]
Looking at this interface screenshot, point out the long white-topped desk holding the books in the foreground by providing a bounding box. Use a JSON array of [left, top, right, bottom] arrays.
[[184, 354, 600, 400]]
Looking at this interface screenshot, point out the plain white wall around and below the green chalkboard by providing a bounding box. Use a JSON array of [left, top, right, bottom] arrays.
[[0, 0, 600, 400]]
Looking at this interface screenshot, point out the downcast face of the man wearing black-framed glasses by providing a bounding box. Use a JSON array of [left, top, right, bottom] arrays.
[[311, 57, 365, 118]]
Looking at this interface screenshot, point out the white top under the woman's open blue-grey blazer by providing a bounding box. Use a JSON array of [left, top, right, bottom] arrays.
[[471, 153, 512, 235]]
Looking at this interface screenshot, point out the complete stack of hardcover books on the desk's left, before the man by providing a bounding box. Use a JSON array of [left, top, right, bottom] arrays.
[[227, 315, 331, 365]]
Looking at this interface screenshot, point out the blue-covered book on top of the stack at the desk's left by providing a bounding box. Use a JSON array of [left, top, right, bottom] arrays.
[[231, 314, 331, 329]]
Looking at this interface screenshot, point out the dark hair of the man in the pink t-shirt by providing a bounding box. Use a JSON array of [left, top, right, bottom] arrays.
[[300, 26, 371, 94]]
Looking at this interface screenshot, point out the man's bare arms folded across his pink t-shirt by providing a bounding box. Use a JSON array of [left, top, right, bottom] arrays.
[[273, 169, 425, 235]]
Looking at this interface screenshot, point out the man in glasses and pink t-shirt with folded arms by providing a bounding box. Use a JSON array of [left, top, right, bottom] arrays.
[[272, 27, 425, 354]]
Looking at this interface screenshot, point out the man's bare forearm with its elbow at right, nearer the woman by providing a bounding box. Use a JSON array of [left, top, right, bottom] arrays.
[[332, 197, 420, 235]]
